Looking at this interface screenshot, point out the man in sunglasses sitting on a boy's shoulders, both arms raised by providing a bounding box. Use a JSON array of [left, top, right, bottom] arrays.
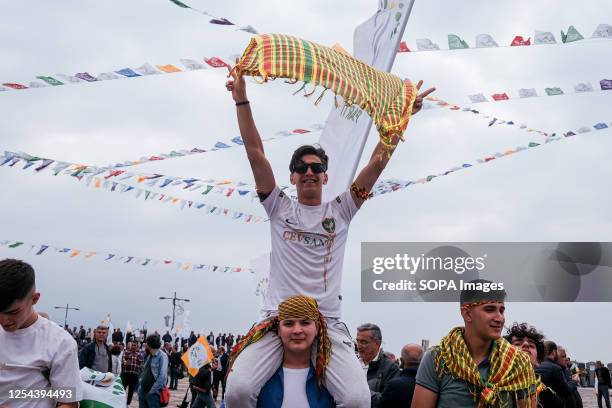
[[226, 61, 435, 408]]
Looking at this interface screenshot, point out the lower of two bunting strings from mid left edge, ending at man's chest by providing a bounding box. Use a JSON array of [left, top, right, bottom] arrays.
[[0, 151, 267, 224]]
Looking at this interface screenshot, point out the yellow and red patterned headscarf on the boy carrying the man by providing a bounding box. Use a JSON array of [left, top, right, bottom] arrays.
[[228, 296, 331, 384]]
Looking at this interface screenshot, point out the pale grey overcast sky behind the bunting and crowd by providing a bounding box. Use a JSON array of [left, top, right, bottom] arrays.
[[0, 0, 612, 361]]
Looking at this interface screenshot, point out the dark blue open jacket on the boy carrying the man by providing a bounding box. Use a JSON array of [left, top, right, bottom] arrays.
[[257, 364, 336, 408]]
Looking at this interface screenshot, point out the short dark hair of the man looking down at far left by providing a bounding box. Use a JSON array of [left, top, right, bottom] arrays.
[[0, 259, 36, 312]]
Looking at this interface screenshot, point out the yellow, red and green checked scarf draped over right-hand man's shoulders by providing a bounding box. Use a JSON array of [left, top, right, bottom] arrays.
[[434, 327, 541, 408]]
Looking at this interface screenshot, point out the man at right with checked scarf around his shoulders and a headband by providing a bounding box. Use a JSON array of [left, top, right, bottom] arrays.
[[412, 279, 540, 408]]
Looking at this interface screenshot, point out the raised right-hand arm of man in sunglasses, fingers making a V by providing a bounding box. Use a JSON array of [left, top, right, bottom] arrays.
[[351, 81, 436, 208]]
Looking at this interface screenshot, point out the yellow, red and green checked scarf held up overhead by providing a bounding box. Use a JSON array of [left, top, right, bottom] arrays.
[[234, 34, 417, 149]]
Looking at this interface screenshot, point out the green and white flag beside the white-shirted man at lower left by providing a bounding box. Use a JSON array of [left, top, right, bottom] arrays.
[[80, 367, 127, 408]]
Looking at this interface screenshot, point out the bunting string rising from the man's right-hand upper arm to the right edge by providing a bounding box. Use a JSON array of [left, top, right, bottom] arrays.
[[372, 122, 612, 197]]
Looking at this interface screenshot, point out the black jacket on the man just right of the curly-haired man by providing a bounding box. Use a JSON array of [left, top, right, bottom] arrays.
[[535, 359, 578, 408]]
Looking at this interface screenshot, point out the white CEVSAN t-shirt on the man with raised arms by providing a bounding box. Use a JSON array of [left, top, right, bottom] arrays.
[[262, 186, 357, 318]]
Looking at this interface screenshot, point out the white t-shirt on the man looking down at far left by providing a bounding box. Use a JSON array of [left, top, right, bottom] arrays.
[[0, 316, 82, 408]]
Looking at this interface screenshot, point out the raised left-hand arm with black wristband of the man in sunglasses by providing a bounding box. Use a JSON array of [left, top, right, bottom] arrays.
[[225, 72, 276, 195]]
